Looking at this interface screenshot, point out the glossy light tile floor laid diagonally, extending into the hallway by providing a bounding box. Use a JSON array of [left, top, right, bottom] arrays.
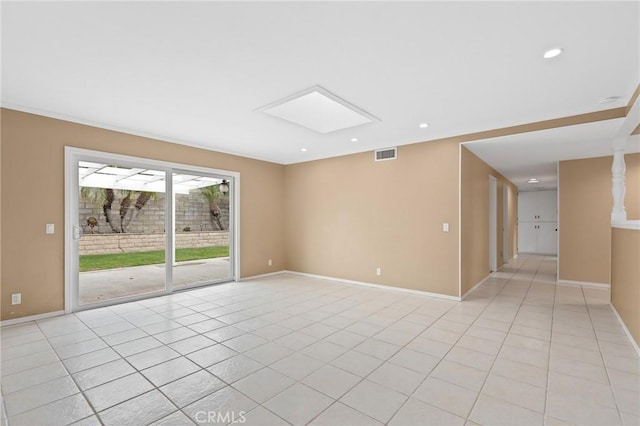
[[1, 256, 640, 426]]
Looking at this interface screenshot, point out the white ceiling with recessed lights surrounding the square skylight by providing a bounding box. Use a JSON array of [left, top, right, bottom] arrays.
[[2, 1, 640, 186]]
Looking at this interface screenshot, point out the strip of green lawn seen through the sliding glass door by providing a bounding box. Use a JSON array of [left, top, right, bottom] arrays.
[[80, 246, 229, 272]]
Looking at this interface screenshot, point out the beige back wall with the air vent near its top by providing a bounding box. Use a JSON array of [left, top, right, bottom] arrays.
[[285, 141, 459, 296]]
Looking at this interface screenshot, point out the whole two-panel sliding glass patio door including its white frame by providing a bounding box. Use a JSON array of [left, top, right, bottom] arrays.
[[65, 148, 239, 312]]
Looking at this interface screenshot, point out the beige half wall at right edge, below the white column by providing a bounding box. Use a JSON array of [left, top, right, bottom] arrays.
[[611, 228, 640, 343]]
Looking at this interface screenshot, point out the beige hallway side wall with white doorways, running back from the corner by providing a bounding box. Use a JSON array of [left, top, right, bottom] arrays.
[[460, 146, 517, 295]]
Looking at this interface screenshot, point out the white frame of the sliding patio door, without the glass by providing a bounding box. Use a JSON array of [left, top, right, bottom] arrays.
[[64, 146, 240, 313]]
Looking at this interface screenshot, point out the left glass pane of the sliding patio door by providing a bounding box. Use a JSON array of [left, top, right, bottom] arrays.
[[78, 161, 167, 306]]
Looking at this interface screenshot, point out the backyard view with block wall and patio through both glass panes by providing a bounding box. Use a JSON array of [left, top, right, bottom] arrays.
[[78, 161, 232, 304]]
